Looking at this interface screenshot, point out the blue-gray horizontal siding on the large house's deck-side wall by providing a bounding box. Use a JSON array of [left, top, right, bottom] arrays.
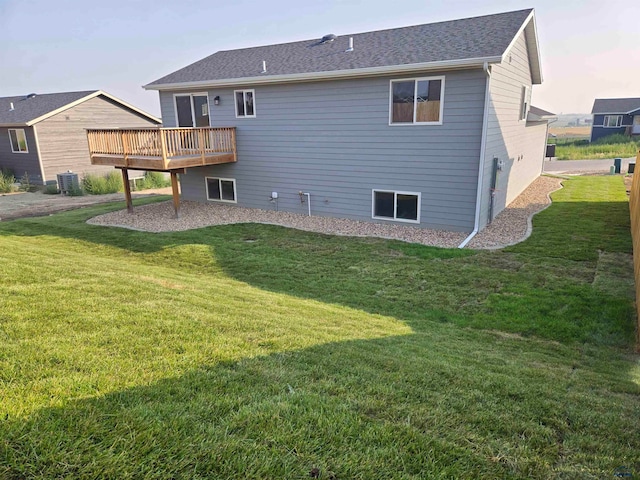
[[160, 70, 485, 231]]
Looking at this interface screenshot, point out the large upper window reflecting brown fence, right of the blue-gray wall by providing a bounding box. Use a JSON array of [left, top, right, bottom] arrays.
[[389, 77, 444, 125]]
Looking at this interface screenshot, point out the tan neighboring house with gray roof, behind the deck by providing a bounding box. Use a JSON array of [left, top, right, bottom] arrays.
[[0, 90, 161, 184]]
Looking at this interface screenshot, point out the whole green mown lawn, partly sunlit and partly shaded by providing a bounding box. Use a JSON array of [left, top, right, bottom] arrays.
[[0, 176, 640, 479]]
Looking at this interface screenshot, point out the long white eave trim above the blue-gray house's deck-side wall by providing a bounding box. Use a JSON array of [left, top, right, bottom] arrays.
[[142, 57, 502, 91]]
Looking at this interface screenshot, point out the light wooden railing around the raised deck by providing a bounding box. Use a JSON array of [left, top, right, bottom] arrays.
[[87, 127, 236, 164]]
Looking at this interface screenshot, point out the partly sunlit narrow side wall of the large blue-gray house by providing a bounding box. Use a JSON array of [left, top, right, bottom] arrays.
[[479, 33, 547, 229]]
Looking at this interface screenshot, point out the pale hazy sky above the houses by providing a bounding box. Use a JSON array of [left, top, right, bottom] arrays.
[[0, 0, 640, 115]]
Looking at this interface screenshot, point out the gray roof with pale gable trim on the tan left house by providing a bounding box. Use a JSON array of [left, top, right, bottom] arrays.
[[0, 90, 161, 127]]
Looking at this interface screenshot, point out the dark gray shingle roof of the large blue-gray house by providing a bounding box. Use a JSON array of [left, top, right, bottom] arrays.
[[144, 9, 542, 90]]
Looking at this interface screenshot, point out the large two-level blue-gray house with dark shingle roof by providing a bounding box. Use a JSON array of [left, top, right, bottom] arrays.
[[89, 9, 547, 240]]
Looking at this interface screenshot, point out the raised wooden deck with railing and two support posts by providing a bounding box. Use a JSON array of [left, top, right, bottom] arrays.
[[87, 127, 238, 217]]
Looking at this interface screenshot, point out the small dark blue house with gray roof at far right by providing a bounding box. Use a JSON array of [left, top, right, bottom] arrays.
[[591, 98, 640, 142]]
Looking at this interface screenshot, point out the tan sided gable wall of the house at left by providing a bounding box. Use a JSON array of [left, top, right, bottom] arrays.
[[36, 96, 155, 180]]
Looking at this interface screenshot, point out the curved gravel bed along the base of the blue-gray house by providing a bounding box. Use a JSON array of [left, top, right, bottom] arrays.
[[88, 177, 560, 248]]
